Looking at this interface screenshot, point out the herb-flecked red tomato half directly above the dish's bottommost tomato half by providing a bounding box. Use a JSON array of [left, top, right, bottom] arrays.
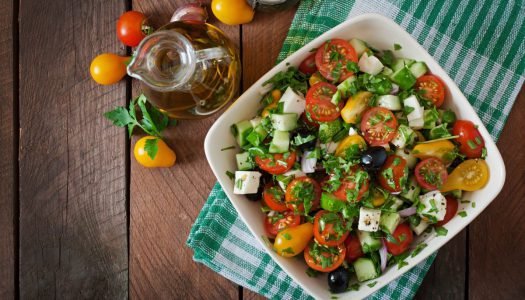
[[314, 210, 349, 247]]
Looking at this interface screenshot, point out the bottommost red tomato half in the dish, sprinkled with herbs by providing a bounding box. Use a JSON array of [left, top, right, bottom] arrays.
[[304, 241, 346, 272]]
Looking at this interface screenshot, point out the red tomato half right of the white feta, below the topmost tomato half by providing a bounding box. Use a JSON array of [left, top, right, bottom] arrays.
[[306, 82, 344, 122]]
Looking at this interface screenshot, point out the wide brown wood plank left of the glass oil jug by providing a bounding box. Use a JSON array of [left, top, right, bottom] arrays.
[[20, 0, 128, 299]]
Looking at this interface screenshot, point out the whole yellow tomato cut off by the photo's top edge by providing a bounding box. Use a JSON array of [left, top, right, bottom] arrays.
[[211, 0, 254, 25]]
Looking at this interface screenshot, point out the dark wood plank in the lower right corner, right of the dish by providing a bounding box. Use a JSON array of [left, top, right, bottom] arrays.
[[468, 86, 525, 299]]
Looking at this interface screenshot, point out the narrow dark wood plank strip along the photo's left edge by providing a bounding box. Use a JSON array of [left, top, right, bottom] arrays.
[[0, 0, 18, 299]]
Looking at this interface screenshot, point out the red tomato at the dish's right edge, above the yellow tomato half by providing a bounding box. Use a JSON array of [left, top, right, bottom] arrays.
[[452, 120, 485, 158]]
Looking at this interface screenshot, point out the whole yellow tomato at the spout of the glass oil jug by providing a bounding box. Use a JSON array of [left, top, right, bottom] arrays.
[[89, 53, 129, 85]]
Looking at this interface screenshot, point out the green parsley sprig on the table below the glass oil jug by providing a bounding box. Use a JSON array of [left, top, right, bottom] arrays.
[[104, 94, 177, 159]]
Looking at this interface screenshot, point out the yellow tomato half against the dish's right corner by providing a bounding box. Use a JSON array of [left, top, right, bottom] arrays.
[[439, 159, 490, 192]]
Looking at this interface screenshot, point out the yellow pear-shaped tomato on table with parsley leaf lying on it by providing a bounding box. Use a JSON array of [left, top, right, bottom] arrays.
[[133, 136, 177, 168]]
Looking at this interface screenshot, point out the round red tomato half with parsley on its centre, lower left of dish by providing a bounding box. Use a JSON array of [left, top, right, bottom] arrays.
[[285, 176, 321, 212]]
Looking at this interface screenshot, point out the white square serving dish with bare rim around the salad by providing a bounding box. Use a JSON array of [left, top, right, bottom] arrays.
[[204, 14, 505, 299]]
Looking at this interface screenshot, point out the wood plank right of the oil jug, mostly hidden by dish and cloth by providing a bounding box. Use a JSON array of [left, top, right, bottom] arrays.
[[242, 7, 297, 300]]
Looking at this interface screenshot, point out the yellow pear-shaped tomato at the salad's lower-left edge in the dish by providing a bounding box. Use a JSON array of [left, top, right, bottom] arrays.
[[273, 223, 314, 257]]
